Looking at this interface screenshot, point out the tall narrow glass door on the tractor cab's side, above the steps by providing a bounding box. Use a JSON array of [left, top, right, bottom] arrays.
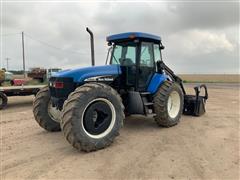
[[137, 42, 156, 91]]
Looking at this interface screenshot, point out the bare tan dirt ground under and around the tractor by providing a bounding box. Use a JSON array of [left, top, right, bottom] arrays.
[[0, 84, 240, 179]]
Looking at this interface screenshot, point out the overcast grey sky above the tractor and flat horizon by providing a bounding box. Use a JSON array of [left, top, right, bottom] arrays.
[[1, 0, 240, 74]]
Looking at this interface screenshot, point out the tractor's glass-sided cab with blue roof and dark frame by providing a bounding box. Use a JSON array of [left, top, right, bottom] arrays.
[[107, 32, 164, 91]]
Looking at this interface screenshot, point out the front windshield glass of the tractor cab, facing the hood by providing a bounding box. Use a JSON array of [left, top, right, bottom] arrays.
[[111, 43, 136, 66]]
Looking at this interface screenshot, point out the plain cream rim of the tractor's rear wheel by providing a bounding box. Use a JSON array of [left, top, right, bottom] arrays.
[[167, 91, 181, 118]]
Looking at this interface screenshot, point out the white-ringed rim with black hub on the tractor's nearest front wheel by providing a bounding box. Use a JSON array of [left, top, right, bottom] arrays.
[[81, 98, 116, 139]]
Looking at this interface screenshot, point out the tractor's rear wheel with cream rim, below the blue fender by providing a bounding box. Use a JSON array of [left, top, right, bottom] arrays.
[[153, 81, 183, 127]]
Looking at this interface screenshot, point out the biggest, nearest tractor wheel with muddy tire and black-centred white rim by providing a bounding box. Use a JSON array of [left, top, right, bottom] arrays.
[[61, 83, 125, 152]]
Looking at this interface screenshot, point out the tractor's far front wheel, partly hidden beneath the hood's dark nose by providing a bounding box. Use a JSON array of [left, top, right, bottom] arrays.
[[33, 87, 61, 132]]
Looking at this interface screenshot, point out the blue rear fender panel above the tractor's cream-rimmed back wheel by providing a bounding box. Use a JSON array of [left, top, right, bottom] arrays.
[[147, 73, 167, 94]]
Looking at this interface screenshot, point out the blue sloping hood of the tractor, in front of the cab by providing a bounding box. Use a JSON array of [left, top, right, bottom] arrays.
[[54, 65, 121, 82]]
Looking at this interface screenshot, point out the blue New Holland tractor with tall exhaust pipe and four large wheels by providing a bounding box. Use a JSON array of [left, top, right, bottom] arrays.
[[33, 28, 206, 152]]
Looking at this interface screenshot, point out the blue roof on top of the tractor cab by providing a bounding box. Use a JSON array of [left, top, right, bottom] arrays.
[[107, 32, 161, 42]]
